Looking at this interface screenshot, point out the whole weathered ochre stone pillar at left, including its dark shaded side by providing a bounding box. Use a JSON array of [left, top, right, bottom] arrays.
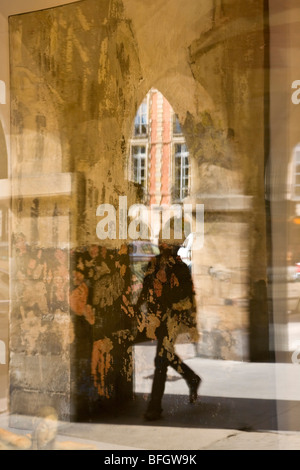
[[10, 0, 140, 420]]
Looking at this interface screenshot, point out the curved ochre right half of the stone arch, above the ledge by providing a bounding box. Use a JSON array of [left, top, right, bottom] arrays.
[[138, 71, 247, 199]]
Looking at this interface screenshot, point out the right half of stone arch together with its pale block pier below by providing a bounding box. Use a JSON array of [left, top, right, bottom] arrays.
[[129, 80, 253, 359]]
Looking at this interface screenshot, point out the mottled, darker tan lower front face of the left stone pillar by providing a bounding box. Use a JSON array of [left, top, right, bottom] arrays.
[[10, 241, 74, 419]]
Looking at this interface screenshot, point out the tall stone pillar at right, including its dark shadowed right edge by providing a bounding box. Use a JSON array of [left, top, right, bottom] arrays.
[[184, 1, 270, 360]]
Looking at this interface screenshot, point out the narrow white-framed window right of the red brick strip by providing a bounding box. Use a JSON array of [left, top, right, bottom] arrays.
[[174, 143, 190, 200]]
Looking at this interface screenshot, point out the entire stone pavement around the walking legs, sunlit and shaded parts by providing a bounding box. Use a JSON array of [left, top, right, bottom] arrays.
[[0, 350, 300, 451]]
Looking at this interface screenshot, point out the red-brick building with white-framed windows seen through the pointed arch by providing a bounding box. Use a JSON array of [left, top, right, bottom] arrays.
[[129, 88, 190, 205]]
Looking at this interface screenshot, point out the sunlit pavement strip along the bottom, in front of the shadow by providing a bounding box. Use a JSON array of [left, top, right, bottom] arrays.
[[0, 415, 300, 452]]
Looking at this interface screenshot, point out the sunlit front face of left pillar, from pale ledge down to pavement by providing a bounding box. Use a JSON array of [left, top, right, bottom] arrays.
[[10, 173, 74, 426]]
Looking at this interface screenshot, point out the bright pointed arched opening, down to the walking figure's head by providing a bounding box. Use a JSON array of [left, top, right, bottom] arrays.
[[126, 87, 192, 266]]
